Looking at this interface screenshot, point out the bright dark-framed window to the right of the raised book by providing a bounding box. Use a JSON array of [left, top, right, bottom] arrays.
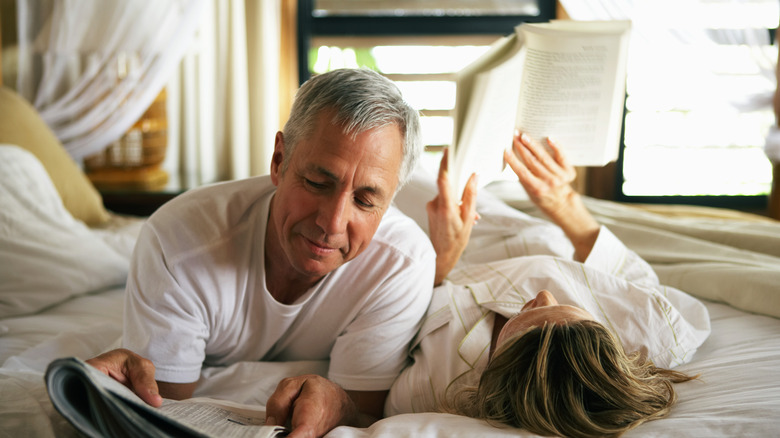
[[617, 0, 778, 208]]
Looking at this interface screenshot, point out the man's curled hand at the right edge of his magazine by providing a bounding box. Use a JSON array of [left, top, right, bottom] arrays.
[[265, 374, 364, 438]]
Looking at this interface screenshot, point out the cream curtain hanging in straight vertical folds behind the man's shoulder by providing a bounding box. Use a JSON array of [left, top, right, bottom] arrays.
[[163, 0, 281, 187]]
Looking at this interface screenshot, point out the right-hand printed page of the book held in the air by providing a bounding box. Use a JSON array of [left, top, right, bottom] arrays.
[[516, 21, 628, 166]]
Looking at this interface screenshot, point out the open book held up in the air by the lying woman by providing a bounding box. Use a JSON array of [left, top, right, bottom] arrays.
[[449, 20, 631, 195]]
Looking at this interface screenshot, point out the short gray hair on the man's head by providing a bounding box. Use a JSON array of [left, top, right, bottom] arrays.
[[282, 68, 422, 191]]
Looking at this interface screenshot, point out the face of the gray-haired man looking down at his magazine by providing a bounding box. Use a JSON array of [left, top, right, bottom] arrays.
[[266, 111, 403, 282]]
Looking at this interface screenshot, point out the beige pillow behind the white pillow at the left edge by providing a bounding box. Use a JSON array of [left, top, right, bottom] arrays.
[[0, 87, 109, 226]]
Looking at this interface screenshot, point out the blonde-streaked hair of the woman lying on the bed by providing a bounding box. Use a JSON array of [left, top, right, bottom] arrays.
[[445, 321, 698, 437]]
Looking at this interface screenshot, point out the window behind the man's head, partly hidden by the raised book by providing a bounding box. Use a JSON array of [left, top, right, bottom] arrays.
[[299, 0, 555, 175]]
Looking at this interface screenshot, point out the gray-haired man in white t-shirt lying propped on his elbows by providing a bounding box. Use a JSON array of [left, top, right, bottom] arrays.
[[89, 69, 435, 436]]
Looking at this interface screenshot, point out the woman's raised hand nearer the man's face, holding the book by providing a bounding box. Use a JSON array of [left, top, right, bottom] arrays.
[[426, 149, 478, 286]]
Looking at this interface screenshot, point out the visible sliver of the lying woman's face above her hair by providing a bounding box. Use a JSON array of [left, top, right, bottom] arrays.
[[495, 290, 595, 348]]
